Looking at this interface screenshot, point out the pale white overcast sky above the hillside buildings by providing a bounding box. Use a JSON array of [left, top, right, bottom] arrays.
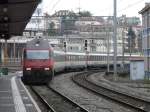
[[41, 0, 150, 17]]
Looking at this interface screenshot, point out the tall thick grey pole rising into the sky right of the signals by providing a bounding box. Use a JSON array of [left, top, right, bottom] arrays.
[[113, 0, 117, 80]]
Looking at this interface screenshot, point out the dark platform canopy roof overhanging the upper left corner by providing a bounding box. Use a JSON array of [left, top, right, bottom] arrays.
[[0, 0, 41, 39]]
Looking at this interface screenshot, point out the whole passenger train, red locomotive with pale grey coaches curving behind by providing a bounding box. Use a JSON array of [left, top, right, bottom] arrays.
[[22, 38, 142, 84]]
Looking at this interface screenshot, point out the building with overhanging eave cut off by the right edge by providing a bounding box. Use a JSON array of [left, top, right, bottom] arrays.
[[139, 3, 150, 79]]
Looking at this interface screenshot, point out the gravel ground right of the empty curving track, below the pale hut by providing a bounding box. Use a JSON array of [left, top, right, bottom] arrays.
[[89, 73, 150, 101]]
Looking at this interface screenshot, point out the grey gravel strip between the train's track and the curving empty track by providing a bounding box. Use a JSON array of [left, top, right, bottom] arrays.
[[50, 73, 133, 112]]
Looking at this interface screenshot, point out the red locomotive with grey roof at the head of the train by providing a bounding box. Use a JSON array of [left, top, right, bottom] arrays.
[[22, 38, 54, 84]]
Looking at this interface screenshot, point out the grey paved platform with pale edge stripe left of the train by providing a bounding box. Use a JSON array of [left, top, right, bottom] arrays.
[[0, 73, 41, 112]]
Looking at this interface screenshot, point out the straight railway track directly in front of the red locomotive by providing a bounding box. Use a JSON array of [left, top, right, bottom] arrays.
[[31, 86, 88, 112]]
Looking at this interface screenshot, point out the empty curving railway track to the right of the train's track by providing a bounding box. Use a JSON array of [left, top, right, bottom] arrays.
[[72, 72, 150, 112]]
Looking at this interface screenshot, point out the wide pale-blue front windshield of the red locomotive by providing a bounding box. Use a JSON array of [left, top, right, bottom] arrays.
[[26, 50, 50, 59]]
